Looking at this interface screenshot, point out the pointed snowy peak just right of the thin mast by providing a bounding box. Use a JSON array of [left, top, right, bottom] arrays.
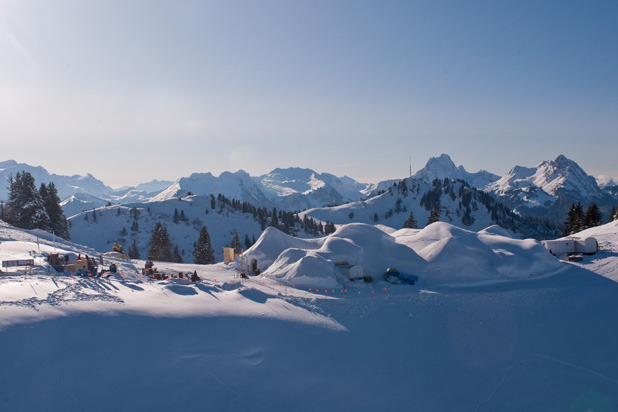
[[412, 154, 500, 189]]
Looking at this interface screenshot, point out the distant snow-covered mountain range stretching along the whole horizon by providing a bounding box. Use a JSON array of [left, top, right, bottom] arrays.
[[0, 154, 618, 232]]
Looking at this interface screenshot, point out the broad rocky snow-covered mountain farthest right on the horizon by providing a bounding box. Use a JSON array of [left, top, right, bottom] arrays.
[[485, 155, 616, 223]]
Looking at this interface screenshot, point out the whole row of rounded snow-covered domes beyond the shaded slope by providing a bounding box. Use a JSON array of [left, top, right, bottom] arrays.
[[246, 222, 562, 288]]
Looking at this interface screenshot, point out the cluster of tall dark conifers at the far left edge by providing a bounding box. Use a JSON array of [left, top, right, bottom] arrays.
[[2, 171, 70, 240]]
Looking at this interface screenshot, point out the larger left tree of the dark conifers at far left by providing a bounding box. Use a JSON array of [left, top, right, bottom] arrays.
[[4, 172, 51, 230]]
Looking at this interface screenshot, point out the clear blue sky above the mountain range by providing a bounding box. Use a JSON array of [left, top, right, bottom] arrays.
[[0, 0, 618, 186]]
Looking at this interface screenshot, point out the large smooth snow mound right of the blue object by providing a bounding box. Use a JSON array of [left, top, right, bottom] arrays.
[[397, 222, 562, 284]]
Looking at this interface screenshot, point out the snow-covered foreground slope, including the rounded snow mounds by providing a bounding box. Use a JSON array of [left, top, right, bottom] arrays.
[[0, 222, 618, 411]]
